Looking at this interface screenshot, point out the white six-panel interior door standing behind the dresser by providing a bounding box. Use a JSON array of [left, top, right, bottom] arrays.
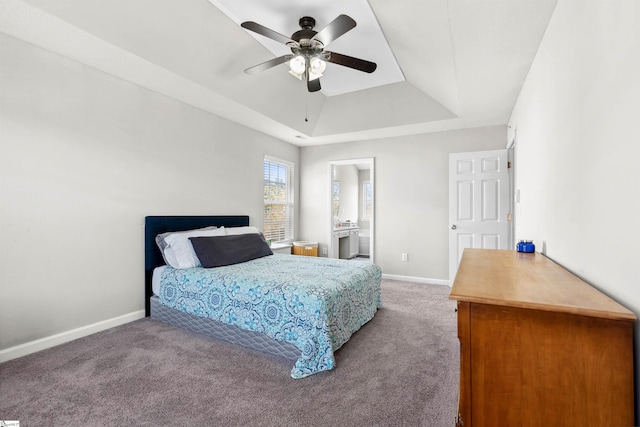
[[449, 150, 509, 284]]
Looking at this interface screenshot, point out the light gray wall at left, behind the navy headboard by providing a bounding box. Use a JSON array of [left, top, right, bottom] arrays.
[[0, 34, 299, 350]]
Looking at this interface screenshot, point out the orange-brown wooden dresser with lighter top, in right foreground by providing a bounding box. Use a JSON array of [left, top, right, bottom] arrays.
[[450, 249, 636, 427]]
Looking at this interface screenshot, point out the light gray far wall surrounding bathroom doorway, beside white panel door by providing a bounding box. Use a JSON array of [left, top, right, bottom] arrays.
[[300, 126, 506, 282]]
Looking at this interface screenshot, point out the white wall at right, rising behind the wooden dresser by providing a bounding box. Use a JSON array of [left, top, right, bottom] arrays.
[[510, 0, 640, 414]]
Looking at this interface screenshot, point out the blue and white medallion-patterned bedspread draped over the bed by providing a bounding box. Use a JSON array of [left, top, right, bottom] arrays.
[[160, 254, 382, 378]]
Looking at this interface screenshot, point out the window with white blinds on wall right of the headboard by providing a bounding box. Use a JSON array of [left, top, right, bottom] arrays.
[[264, 156, 294, 242]]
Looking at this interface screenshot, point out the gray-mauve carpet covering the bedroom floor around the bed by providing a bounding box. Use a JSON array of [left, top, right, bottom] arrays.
[[0, 280, 459, 427]]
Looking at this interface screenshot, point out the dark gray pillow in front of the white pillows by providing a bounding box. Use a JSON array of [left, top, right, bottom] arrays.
[[189, 233, 273, 268]]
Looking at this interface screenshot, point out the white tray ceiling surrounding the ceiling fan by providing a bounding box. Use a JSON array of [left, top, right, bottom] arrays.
[[0, 0, 556, 146]]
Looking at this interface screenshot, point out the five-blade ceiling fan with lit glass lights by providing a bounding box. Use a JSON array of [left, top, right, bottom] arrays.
[[240, 15, 377, 92]]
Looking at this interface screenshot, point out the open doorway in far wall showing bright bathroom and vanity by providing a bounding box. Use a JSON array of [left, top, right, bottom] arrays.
[[327, 158, 375, 262]]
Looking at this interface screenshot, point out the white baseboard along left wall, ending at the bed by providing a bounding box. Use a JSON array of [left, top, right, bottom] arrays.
[[0, 310, 145, 363]]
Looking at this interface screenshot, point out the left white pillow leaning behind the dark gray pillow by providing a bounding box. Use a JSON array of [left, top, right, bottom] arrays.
[[156, 227, 226, 268]]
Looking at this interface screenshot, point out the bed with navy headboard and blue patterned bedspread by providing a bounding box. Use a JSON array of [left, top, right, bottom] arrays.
[[145, 215, 381, 379]]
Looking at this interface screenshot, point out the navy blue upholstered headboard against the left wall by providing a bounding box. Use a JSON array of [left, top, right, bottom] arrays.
[[144, 215, 249, 316]]
